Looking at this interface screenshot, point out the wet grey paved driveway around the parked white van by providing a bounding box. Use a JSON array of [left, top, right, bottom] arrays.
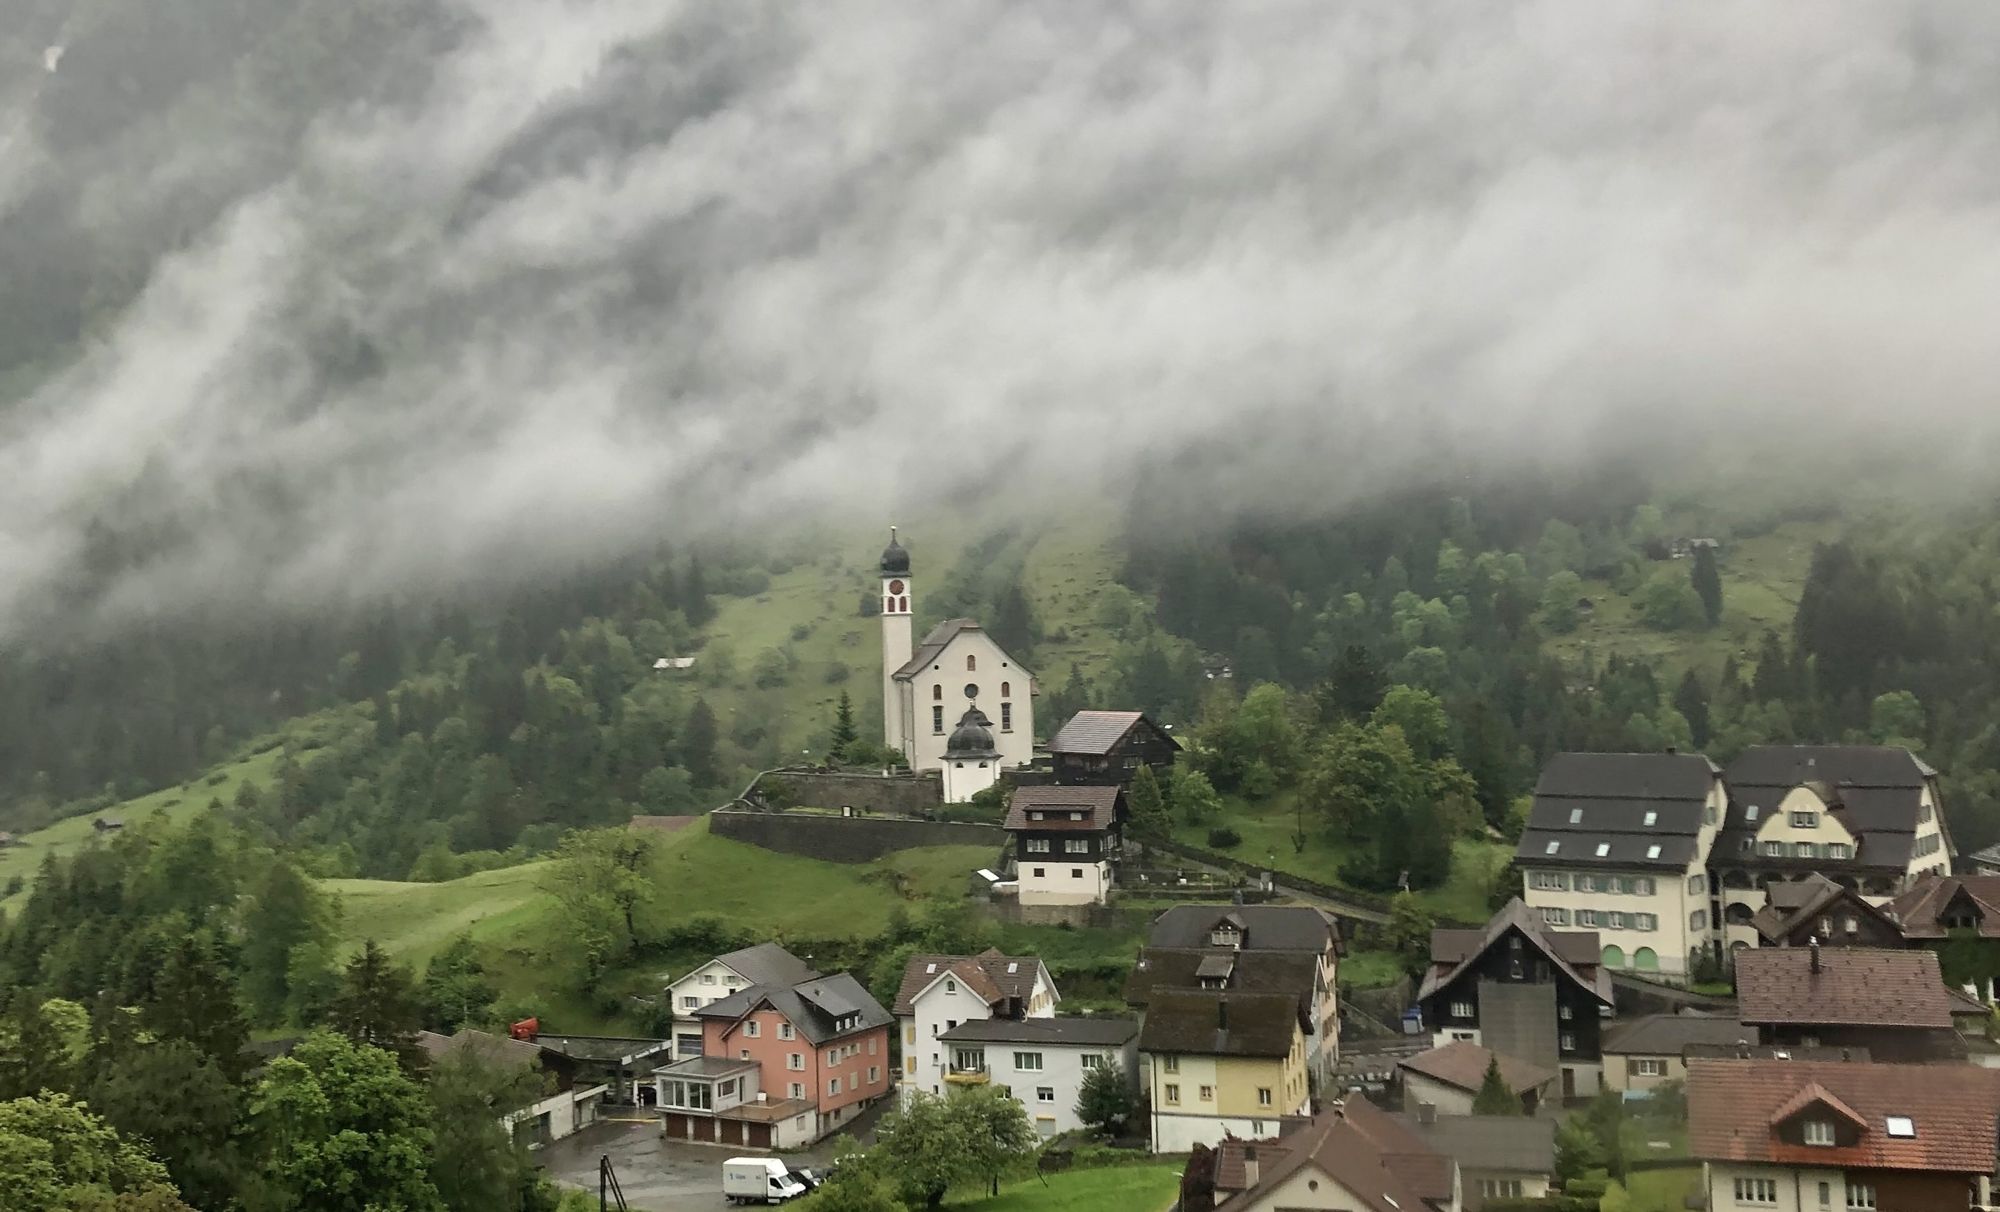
[[536, 1098, 896, 1212]]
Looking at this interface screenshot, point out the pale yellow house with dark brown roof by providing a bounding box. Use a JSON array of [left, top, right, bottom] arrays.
[[1138, 990, 1312, 1154]]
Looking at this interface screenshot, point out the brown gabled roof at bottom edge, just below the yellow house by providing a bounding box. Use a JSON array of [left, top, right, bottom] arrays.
[[1216, 1098, 1458, 1212]]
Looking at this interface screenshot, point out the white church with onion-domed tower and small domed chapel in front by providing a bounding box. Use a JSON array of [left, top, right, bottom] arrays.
[[882, 528, 1034, 804]]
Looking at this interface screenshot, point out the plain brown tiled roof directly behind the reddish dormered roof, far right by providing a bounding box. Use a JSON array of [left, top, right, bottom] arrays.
[[1736, 946, 1952, 1028]]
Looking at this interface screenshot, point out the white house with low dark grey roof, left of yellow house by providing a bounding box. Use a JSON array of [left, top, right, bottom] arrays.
[[938, 1016, 1138, 1136]]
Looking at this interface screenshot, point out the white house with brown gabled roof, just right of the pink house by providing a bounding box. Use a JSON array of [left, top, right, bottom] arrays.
[[894, 950, 1062, 1096]]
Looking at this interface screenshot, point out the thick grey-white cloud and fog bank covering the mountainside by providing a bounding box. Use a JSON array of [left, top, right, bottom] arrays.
[[0, 0, 2000, 640]]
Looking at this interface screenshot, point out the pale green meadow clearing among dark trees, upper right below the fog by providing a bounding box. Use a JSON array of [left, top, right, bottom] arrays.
[[1548, 522, 1840, 680]]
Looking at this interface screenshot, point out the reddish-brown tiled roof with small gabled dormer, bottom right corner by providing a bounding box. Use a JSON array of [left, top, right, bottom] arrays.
[[1688, 1058, 2000, 1174]]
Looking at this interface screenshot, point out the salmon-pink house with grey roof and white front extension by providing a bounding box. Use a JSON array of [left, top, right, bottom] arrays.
[[654, 972, 894, 1148]]
